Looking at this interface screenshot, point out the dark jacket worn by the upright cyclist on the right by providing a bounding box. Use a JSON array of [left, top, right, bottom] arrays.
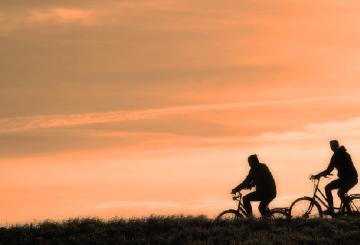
[[323, 146, 358, 180]]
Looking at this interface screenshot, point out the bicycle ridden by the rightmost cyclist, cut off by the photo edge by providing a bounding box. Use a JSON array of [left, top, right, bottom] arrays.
[[289, 177, 360, 218]]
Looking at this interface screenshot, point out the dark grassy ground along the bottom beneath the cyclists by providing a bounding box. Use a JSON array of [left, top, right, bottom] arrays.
[[0, 217, 360, 245]]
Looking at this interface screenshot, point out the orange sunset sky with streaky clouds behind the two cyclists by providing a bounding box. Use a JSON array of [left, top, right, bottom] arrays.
[[0, 0, 360, 224]]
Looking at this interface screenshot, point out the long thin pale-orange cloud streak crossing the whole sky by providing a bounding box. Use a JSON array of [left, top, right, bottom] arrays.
[[0, 97, 359, 133]]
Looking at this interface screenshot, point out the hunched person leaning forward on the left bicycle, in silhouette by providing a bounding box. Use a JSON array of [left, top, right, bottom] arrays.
[[231, 155, 276, 217]]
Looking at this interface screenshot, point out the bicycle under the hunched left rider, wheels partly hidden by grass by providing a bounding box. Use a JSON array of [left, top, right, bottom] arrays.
[[215, 192, 290, 221]]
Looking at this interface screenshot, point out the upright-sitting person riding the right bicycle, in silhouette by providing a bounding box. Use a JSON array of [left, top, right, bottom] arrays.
[[311, 140, 358, 215]]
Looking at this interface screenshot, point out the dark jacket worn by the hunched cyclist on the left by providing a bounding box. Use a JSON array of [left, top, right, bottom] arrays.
[[236, 163, 276, 196]]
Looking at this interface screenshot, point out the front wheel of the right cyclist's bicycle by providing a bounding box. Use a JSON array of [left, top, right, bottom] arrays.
[[290, 197, 323, 219]]
